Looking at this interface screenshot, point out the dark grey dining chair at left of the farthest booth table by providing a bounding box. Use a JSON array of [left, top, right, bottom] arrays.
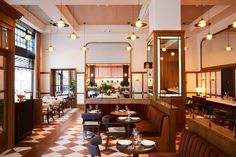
[[81, 113, 101, 139]]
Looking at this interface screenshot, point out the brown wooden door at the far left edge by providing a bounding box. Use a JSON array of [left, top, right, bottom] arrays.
[[0, 52, 8, 152]]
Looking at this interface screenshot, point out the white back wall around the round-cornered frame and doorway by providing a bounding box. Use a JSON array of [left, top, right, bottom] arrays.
[[40, 32, 148, 104]]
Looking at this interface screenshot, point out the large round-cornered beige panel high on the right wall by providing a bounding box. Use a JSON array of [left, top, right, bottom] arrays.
[[201, 28, 236, 69]]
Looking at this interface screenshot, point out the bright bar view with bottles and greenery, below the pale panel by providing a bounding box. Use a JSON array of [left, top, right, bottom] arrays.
[[86, 64, 130, 99]]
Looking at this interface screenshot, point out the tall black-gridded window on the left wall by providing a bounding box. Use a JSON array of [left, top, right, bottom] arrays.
[[15, 24, 35, 97]]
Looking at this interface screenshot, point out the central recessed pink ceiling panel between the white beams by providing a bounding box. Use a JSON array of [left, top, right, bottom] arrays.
[[67, 5, 140, 25]]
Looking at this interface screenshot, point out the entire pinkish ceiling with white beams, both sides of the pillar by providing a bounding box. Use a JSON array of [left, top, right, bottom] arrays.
[[5, 0, 236, 32]]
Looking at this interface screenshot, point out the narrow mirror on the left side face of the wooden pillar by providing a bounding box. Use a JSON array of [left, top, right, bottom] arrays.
[[145, 40, 154, 95]]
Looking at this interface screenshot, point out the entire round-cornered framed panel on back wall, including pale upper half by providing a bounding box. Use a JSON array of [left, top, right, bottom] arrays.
[[85, 42, 132, 99]]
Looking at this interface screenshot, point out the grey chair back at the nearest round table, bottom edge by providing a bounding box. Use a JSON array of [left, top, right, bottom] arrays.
[[88, 135, 102, 157]]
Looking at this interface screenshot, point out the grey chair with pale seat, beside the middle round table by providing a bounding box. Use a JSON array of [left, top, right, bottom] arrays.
[[102, 115, 126, 150]]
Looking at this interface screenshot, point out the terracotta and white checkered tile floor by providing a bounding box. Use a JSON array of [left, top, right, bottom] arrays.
[[0, 109, 180, 157]]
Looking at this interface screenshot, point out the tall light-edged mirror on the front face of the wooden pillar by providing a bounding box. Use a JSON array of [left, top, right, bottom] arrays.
[[157, 36, 182, 96]]
